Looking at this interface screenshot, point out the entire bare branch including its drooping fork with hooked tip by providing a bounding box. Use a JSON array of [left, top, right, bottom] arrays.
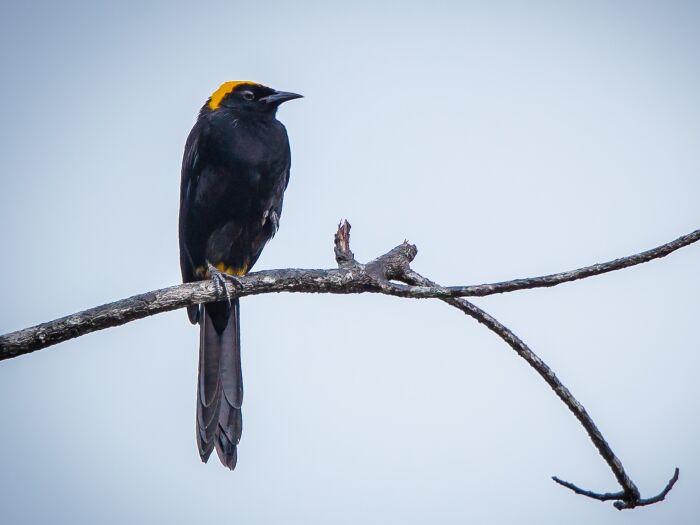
[[0, 221, 700, 510]]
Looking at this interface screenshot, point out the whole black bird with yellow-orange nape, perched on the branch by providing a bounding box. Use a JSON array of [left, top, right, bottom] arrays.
[[178, 80, 302, 470]]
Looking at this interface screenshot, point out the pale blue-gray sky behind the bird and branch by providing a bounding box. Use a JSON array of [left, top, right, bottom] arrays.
[[0, 1, 700, 524]]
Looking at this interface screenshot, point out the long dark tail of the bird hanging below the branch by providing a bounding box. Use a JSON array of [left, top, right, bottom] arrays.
[[197, 299, 243, 470]]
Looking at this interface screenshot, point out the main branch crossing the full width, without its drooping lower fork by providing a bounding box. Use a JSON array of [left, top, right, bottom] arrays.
[[0, 226, 700, 361]]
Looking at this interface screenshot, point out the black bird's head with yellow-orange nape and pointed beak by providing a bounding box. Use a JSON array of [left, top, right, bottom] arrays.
[[202, 80, 302, 114]]
